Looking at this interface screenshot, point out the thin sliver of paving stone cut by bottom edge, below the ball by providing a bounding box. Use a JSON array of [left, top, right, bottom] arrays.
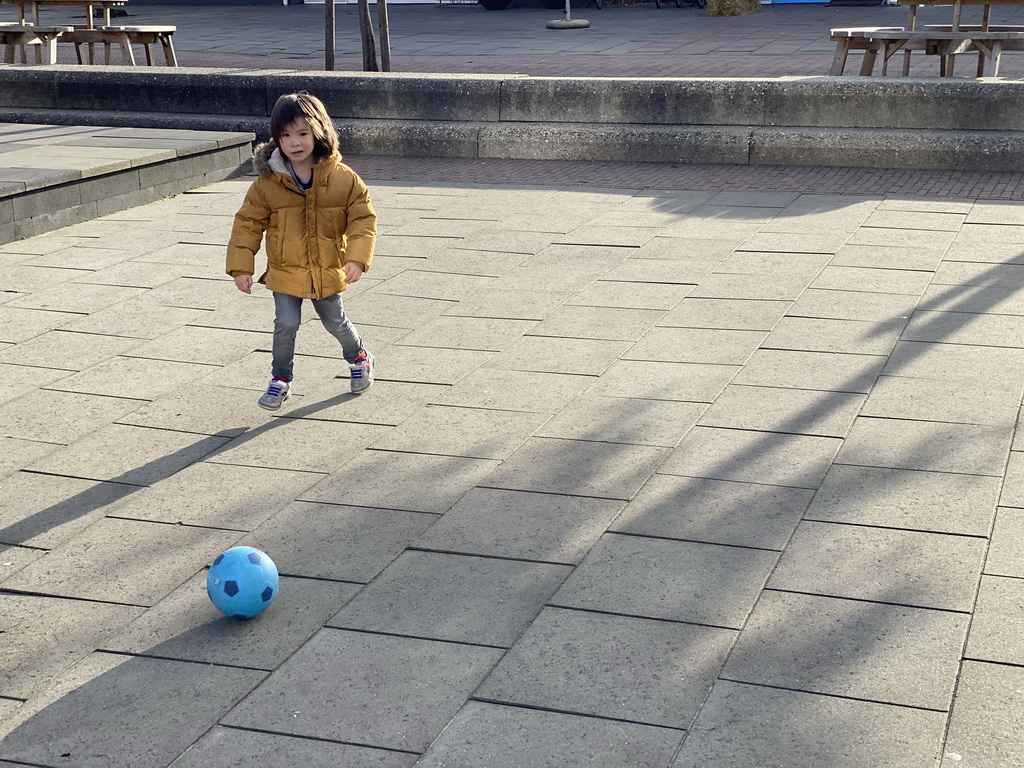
[[165, 726, 419, 768]]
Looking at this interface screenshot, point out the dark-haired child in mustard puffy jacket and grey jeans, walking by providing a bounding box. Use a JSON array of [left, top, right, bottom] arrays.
[[227, 92, 377, 411]]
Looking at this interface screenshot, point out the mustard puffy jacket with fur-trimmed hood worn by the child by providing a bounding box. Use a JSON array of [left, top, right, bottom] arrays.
[[227, 142, 377, 299]]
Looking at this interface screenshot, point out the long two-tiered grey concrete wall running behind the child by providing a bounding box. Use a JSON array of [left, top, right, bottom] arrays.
[[0, 67, 1024, 171]]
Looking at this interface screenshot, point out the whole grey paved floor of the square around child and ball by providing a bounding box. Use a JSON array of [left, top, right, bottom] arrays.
[[0, 140, 1024, 768]]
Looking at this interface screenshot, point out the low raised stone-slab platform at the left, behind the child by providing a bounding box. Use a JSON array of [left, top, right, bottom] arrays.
[[0, 123, 253, 244]]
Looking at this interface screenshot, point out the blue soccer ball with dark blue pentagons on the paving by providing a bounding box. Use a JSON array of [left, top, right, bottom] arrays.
[[206, 547, 279, 618]]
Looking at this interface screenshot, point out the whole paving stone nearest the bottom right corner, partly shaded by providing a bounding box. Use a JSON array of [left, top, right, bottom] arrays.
[[722, 590, 970, 711]]
